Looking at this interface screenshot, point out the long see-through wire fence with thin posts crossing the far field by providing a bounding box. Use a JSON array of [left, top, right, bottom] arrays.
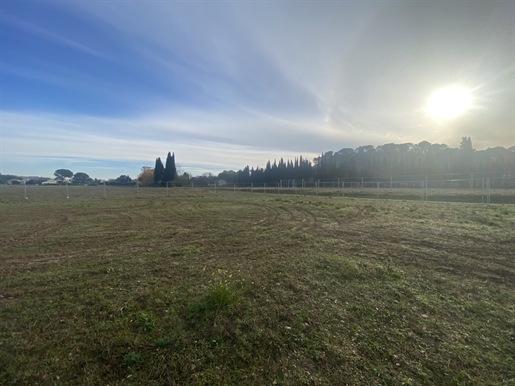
[[0, 176, 515, 204]]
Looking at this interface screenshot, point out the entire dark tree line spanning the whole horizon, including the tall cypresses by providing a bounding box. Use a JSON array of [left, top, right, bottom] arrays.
[[0, 137, 515, 186]]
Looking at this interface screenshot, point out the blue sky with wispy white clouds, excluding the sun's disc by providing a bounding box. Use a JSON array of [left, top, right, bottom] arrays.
[[0, 0, 515, 178]]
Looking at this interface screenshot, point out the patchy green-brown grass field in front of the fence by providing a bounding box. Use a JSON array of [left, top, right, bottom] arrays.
[[0, 187, 515, 385]]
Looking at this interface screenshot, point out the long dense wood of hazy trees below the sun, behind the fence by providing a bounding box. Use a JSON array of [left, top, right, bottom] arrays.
[[230, 137, 515, 184]]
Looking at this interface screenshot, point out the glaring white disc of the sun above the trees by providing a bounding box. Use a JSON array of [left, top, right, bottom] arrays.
[[426, 86, 472, 119]]
